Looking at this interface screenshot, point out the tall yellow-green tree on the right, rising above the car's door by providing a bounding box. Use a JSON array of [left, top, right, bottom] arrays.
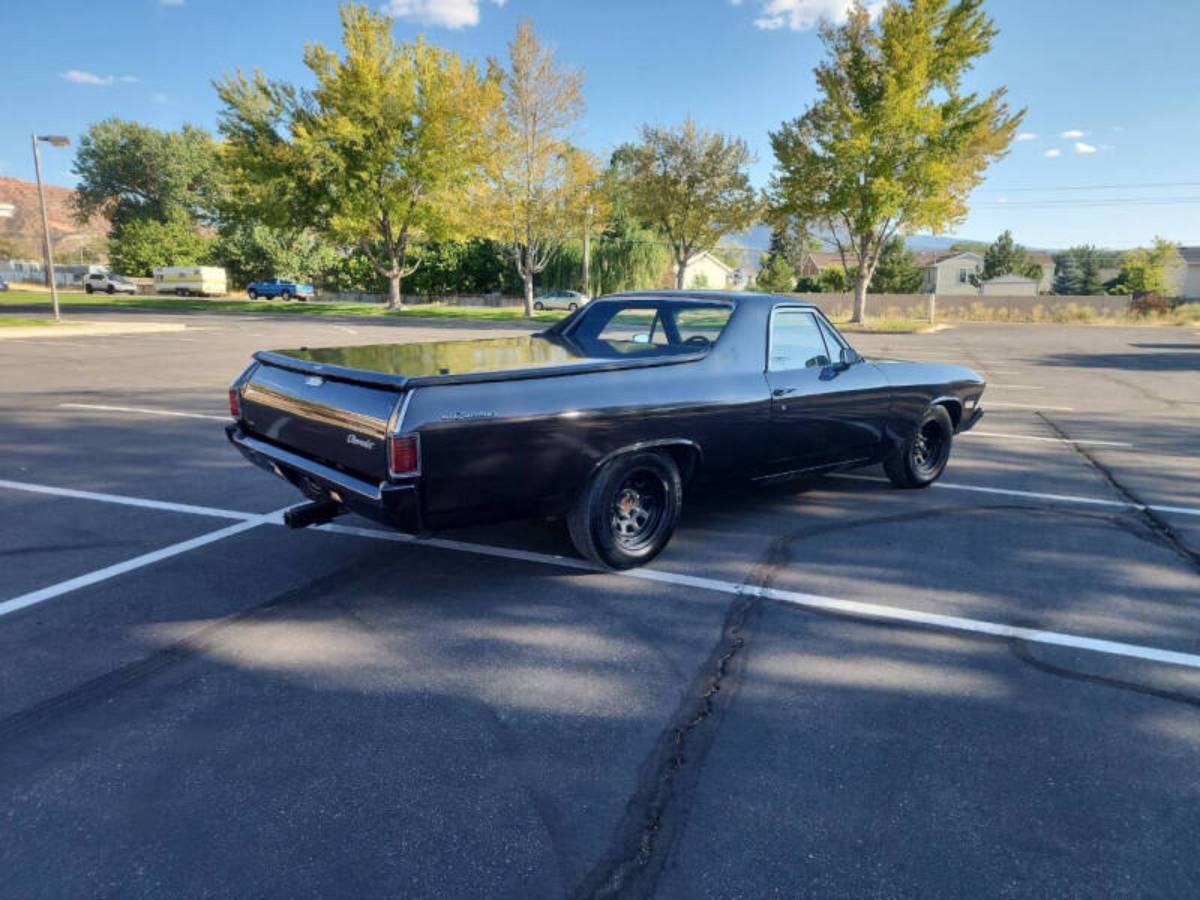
[[770, 0, 1024, 322]]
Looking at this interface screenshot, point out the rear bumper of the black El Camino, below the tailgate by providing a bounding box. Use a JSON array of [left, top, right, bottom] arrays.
[[226, 422, 424, 534]]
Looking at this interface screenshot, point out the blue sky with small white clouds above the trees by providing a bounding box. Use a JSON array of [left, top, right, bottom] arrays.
[[0, 0, 1200, 247]]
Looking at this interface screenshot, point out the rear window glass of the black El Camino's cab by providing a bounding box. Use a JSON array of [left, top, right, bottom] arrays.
[[566, 300, 733, 356]]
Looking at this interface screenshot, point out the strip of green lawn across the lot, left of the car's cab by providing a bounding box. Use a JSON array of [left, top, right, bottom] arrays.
[[0, 290, 566, 323]]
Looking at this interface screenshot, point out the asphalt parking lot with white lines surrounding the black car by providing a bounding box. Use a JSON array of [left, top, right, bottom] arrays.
[[0, 314, 1200, 898]]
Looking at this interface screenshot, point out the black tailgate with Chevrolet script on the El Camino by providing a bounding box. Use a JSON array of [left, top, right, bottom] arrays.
[[241, 365, 403, 481]]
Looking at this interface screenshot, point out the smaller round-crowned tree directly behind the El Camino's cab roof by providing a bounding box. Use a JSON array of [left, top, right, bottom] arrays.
[[614, 118, 763, 289]]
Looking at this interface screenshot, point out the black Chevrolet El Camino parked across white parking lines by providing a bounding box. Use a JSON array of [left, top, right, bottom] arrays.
[[228, 292, 985, 568]]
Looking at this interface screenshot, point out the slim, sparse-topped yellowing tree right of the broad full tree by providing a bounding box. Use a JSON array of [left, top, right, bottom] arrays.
[[481, 20, 588, 316]]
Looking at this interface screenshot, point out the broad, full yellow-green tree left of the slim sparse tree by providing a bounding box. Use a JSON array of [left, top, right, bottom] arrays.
[[217, 4, 499, 308]]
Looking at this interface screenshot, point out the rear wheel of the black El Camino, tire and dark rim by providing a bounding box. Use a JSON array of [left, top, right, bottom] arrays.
[[566, 452, 683, 569]]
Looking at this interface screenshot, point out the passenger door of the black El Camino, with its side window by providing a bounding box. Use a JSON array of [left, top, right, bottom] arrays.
[[767, 306, 890, 470]]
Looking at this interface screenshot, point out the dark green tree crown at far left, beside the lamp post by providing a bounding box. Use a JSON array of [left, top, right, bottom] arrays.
[[72, 119, 220, 229]]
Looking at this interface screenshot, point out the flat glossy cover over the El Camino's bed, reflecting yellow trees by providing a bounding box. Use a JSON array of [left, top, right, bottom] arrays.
[[254, 335, 707, 390]]
